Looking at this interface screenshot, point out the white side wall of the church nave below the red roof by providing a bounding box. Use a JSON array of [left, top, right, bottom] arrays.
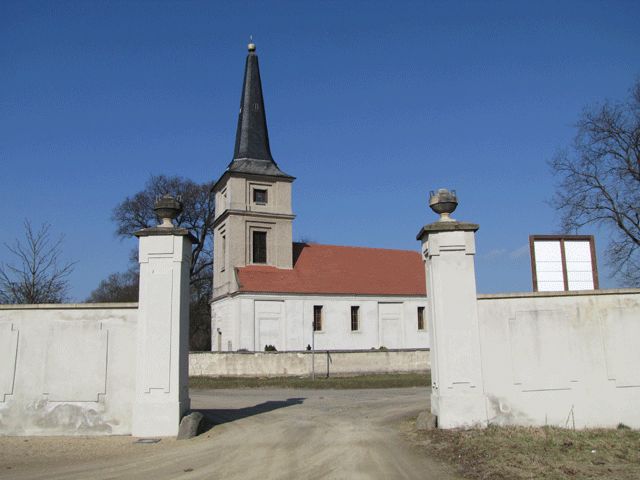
[[211, 294, 429, 352]]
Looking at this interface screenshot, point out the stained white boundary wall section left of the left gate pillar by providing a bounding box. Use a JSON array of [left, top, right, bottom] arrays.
[[0, 304, 138, 435]]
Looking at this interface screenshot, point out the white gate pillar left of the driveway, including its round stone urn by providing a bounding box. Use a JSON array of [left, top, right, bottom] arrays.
[[132, 196, 196, 437]]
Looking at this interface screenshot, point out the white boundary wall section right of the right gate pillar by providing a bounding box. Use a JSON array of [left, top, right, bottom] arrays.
[[478, 290, 640, 428]]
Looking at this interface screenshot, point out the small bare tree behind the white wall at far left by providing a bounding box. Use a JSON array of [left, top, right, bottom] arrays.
[[0, 221, 74, 303]]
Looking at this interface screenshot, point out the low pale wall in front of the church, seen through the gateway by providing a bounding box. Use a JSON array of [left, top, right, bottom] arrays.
[[189, 349, 431, 377]]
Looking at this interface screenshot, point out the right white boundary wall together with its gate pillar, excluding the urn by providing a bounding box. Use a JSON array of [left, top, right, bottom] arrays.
[[418, 219, 640, 428]]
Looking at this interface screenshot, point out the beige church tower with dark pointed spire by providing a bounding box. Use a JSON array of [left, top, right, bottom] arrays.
[[213, 43, 295, 300]]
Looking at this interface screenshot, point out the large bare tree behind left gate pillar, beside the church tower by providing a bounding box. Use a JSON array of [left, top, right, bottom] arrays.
[[105, 175, 215, 350]]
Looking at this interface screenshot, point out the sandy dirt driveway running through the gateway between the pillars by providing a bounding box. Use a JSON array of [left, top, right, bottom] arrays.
[[0, 388, 458, 480]]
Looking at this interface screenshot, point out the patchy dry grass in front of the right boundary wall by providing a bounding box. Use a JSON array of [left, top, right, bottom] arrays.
[[414, 426, 640, 480]]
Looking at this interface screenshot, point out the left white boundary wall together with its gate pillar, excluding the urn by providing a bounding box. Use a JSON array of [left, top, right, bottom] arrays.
[[0, 226, 194, 437]]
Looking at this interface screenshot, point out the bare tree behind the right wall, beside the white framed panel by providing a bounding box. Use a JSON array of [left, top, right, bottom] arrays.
[[551, 79, 640, 285]]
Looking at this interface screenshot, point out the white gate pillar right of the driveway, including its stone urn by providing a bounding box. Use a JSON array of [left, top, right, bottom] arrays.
[[417, 190, 487, 428]]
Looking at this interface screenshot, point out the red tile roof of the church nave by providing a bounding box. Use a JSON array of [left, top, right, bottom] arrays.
[[236, 243, 426, 295]]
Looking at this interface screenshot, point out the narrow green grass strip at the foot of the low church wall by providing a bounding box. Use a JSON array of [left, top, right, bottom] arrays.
[[189, 373, 431, 390]]
